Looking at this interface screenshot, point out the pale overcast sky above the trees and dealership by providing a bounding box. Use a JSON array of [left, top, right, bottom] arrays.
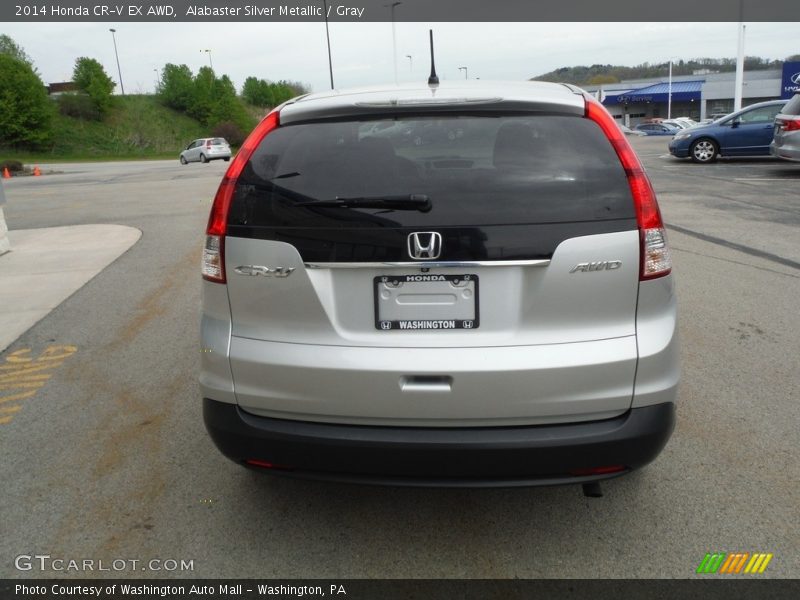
[[0, 22, 800, 93]]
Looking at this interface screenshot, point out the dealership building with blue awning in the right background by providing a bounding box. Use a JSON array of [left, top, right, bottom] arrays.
[[584, 62, 800, 127]]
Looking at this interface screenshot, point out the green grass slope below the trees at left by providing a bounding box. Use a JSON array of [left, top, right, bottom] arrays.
[[0, 96, 211, 163]]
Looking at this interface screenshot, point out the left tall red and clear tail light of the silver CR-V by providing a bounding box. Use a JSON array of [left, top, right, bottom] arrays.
[[202, 111, 280, 283]]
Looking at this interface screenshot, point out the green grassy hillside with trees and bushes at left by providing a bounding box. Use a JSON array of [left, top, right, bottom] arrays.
[[0, 35, 307, 163]]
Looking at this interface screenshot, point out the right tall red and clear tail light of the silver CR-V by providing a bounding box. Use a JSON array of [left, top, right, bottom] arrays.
[[585, 96, 672, 281]]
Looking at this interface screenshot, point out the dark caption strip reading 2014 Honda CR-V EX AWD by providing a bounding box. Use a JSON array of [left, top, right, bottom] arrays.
[[0, 0, 800, 23]]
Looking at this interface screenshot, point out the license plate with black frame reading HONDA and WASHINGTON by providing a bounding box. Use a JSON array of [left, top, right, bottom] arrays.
[[372, 273, 480, 332]]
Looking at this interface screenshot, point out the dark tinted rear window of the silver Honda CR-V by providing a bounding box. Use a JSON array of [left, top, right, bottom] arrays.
[[229, 115, 634, 227]]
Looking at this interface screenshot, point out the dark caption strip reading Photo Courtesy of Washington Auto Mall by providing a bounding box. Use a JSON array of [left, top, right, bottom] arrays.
[[0, 575, 800, 600]]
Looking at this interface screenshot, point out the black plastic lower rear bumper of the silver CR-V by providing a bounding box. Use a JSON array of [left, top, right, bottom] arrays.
[[203, 398, 675, 487]]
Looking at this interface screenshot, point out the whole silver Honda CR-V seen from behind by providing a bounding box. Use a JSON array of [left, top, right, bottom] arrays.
[[200, 82, 679, 486]]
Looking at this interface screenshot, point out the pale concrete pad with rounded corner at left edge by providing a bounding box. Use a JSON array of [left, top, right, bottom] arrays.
[[0, 225, 142, 352]]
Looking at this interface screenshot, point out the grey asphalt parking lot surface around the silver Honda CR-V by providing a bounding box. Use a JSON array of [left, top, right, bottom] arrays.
[[0, 138, 800, 578]]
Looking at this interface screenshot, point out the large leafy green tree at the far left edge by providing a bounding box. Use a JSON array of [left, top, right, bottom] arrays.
[[0, 53, 53, 147]]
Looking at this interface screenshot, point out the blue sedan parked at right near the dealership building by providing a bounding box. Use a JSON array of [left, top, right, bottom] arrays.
[[669, 100, 787, 163]]
